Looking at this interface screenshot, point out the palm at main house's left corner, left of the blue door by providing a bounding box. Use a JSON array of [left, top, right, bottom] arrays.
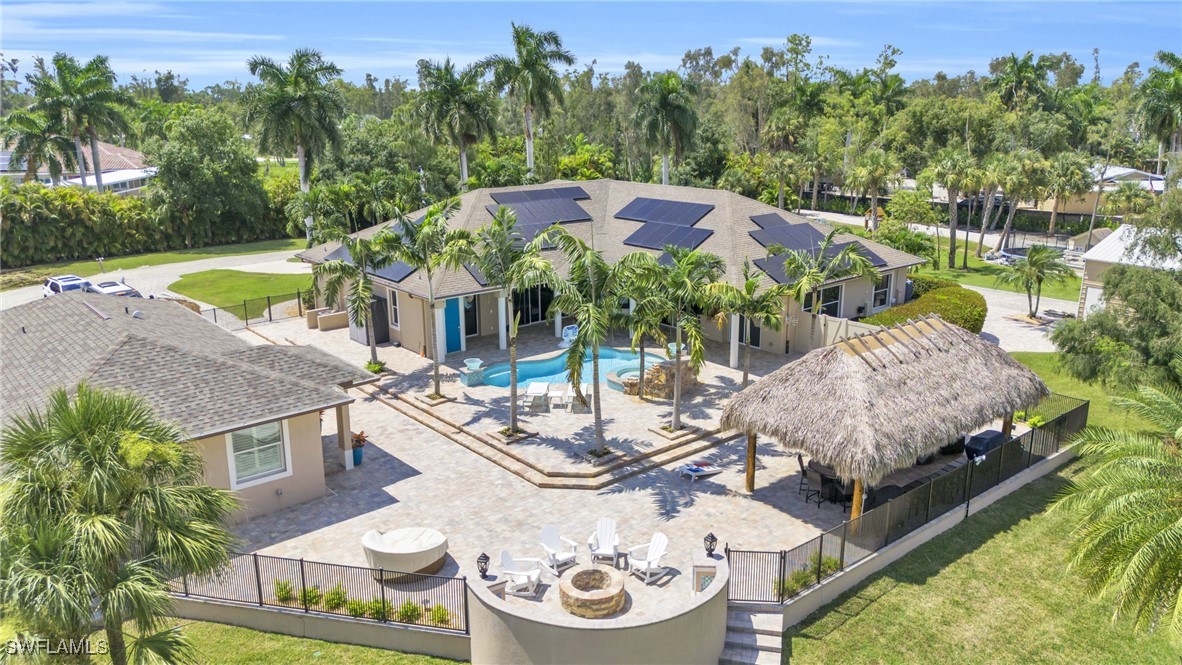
[[312, 227, 394, 365]]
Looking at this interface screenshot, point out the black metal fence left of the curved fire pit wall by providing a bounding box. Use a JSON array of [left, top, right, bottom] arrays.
[[170, 554, 468, 633]]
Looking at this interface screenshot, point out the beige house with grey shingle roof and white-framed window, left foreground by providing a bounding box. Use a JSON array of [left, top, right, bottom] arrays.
[[0, 292, 377, 517]]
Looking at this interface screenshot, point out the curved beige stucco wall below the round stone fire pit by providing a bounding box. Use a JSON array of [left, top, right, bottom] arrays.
[[468, 560, 729, 665]]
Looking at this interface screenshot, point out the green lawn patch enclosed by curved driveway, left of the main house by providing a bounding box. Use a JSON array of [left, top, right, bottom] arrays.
[[168, 269, 312, 319]]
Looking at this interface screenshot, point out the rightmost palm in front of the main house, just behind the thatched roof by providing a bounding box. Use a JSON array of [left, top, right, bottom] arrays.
[[767, 228, 878, 348]]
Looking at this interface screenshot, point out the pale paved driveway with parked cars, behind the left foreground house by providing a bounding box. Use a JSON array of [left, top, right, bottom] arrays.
[[0, 250, 312, 309]]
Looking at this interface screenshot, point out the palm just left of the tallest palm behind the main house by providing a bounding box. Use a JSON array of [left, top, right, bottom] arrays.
[[416, 58, 496, 189]]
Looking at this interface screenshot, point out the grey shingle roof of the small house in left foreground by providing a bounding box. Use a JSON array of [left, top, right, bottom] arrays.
[[0, 292, 374, 438]]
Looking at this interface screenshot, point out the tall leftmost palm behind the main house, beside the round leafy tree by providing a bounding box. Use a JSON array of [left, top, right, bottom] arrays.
[[242, 48, 345, 245]]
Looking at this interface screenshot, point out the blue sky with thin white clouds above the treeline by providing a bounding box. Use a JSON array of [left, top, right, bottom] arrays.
[[0, 0, 1182, 89]]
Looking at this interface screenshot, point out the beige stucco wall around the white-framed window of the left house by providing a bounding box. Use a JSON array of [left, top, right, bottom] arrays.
[[194, 412, 325, 520]]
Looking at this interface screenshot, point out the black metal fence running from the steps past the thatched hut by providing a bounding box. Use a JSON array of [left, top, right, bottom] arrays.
[[726, 395, 1087, 602]]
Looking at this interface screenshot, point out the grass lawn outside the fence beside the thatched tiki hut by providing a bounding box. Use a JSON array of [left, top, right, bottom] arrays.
[[784, 353, 1158, 665]]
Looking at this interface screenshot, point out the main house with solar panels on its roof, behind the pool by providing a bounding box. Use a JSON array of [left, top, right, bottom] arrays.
[[300, 180, 923, 363]]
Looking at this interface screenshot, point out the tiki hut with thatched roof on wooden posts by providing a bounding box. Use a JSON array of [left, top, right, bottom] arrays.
[[721, 317, 1050, 519]]
